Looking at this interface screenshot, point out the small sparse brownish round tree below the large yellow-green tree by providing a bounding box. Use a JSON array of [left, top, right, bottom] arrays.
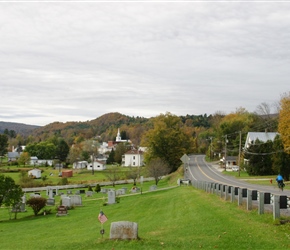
[[146, 158, 170, 185]]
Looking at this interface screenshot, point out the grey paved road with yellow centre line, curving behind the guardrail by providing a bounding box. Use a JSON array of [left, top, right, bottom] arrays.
[[186, 155, 290, 197]]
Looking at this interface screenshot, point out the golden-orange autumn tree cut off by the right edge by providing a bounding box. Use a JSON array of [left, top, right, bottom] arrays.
[[278, 92, 290, 154]]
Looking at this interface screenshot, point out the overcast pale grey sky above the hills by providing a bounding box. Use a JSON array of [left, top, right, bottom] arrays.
[[0, 0, 290, 126]]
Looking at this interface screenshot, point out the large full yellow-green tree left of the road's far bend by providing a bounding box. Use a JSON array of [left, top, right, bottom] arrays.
[[142, 113, 195, 172]]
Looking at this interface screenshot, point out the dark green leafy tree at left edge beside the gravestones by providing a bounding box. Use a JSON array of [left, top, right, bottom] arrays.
[[0, 175, 23, 219]]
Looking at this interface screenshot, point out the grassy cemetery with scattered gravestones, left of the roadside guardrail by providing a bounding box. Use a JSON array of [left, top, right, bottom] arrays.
[[0, 170, 289, 250]]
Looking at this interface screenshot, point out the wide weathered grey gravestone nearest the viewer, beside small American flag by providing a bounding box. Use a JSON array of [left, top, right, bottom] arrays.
[[110, 221, 138, 240]]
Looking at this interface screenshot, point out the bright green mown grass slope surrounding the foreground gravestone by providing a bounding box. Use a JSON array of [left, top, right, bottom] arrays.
[[0, 181, 290, 250]]
